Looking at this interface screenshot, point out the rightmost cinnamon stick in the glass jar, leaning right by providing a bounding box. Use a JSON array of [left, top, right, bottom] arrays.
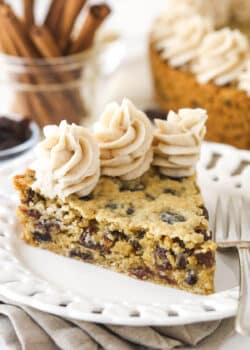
[[69, 3, 111, 54]]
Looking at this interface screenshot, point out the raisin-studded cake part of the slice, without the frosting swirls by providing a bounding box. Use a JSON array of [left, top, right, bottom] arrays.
[[14, 168, 216, 294]]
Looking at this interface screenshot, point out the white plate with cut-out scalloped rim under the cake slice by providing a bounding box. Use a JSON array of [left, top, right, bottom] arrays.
[[0, 143, 250, 326]]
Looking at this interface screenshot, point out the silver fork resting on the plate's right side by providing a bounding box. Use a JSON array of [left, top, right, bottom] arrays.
[[212, 197, 250, 336]]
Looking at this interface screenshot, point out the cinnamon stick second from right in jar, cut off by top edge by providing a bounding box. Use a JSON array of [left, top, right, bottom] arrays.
[[59, 0, 86, 51]]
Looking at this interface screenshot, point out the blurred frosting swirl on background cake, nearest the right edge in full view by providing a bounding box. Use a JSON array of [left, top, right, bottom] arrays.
[[192, 28, 249, 85]]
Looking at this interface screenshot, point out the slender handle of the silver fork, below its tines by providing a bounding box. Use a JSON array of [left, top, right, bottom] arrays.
[[235, 247, 250, 336]]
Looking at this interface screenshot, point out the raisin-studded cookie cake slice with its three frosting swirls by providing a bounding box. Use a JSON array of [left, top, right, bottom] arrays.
[[14, 100, 216, 294]]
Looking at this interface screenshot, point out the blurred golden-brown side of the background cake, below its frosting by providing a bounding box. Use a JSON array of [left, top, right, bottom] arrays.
[[149, 44, 250, 149]]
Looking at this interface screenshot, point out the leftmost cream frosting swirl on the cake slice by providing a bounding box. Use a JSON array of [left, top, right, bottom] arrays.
[[31, 121, 100, 199]]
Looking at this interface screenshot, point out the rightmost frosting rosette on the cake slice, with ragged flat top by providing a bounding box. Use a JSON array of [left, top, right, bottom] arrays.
[[153, 109, 207, 177]]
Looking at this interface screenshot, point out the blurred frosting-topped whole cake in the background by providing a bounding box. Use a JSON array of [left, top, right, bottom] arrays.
[[149, 0, 250, 149]]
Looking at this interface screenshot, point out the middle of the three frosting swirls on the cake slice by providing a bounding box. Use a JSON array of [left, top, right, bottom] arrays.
[[94, 99, 153, 180]]
